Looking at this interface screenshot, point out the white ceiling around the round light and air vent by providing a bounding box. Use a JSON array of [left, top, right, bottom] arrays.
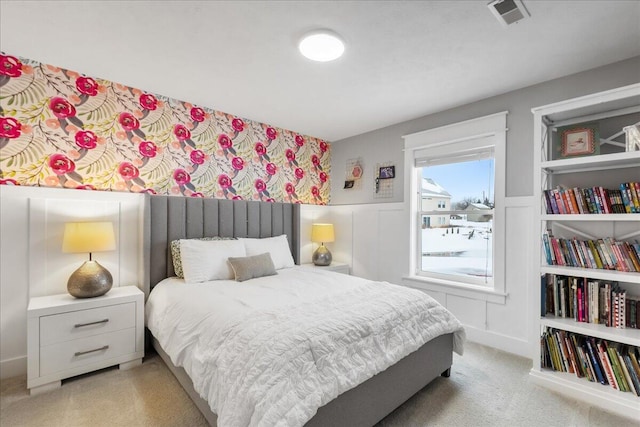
[[0, 0, 640, 141]]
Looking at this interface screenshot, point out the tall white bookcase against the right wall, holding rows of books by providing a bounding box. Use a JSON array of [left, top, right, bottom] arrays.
[[530, 83, 640, 419]]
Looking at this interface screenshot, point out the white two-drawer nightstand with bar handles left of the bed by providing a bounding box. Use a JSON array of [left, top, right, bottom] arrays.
[[27, 286, 144, 394]]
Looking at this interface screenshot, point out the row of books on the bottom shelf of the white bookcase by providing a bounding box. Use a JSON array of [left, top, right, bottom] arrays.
[[540, 328, 640, 396]]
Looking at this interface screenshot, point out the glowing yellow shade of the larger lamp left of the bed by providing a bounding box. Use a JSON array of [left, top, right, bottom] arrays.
[[62, 222, 116, 253]]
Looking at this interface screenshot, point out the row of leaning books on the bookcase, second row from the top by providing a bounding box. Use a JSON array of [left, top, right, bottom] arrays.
[[542, 231, 640, 272]]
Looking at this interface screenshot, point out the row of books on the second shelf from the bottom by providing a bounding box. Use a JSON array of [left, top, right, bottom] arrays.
[[540, 273, 640, 329]]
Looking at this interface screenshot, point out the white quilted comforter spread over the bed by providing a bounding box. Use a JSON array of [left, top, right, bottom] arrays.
[[146, 267, 464, 426]]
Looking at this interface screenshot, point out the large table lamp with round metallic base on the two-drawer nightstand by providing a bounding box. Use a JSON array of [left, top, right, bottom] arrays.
[[62, 222, 116, 298]]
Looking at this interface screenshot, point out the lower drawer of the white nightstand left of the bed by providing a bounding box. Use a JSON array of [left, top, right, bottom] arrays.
[[40, 327, 136, 376]]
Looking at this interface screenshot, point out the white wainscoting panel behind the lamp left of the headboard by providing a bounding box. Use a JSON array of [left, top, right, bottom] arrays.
[[0, 185, 144, 378]]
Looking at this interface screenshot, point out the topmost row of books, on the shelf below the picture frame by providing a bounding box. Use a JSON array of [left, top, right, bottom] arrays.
[[544, 182, 640, 214]]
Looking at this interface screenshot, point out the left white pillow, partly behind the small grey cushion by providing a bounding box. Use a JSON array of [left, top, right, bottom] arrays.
[[180, 239, 247, 283]]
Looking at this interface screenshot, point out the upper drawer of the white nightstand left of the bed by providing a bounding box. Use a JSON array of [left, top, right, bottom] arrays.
[[40, 302, 136, 347]]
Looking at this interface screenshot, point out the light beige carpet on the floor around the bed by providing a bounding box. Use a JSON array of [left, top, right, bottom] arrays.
[[0, 343, 640, 427]]
